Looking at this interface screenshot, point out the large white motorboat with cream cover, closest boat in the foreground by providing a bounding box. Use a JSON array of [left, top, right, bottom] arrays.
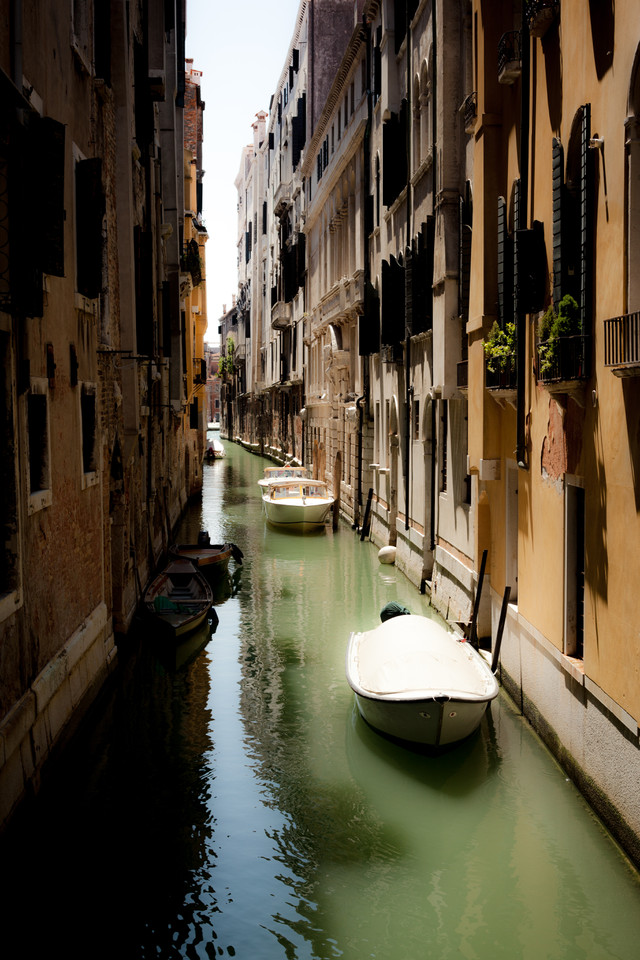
[[346, 615, 499, 747]]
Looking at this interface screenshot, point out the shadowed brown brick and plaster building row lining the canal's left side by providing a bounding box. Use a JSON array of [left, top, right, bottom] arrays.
[[0, 0, 204, 822]]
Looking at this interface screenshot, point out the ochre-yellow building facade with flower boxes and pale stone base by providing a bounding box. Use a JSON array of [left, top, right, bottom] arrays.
[[467, 0, 640, 862]]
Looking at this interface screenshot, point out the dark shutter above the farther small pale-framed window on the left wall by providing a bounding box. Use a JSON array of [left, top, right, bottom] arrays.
[[76, 157, 105, 299]]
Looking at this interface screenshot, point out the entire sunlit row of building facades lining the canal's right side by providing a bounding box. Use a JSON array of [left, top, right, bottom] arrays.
[[220, 0, 640, 862]]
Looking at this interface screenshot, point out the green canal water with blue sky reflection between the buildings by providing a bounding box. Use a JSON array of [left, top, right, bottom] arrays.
[[0, 443, 640, 960]]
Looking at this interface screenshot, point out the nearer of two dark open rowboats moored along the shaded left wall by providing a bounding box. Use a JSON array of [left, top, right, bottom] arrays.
[[144, 558, 213, 638]]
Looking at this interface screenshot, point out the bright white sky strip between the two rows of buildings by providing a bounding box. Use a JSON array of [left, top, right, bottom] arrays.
[[186, 0, 300, 342]]
